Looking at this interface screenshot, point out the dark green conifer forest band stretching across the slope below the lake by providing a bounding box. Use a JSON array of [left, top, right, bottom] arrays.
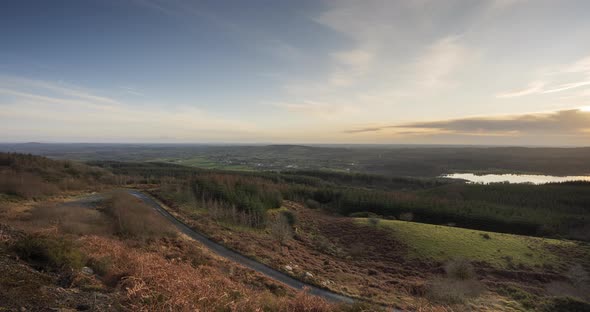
[[92, 162, 590, 240]]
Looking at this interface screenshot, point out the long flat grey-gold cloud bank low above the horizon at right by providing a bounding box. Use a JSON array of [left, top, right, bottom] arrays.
[[345, 109, 590, 136]]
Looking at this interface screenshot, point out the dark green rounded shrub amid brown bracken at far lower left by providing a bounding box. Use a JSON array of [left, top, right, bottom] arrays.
[[13, 236, 85, 270]]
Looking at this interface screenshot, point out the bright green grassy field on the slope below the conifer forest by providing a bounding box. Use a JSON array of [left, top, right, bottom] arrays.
[[357, 218, 587, 268]]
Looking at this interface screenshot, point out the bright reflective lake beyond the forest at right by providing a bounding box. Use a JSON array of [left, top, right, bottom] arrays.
[[441, 173, 590, 184]]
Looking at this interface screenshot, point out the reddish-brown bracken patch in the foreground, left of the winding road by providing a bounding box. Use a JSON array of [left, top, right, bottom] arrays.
[[82, 236, 336, 312]]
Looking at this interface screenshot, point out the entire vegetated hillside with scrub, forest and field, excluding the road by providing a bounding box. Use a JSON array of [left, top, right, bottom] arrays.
[[0, 154, 590, 311]]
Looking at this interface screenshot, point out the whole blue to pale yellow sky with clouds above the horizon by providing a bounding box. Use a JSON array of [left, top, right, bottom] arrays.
[[0, 0, 590, 146]]
